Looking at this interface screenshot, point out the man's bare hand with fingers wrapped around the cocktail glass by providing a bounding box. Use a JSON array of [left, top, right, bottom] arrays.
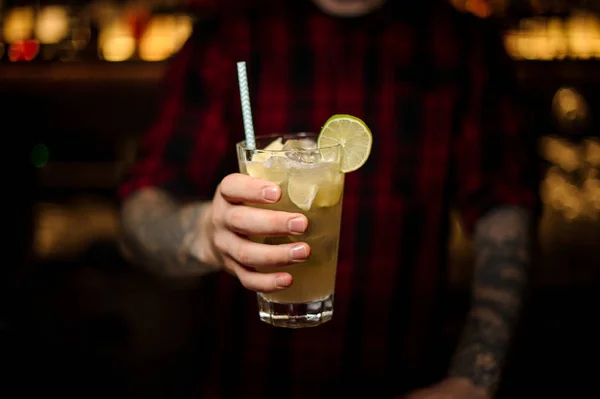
[[197, 173, 310, 292]]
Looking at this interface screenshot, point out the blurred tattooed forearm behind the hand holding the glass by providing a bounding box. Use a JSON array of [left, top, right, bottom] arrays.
[[121, 189, 215, 277]]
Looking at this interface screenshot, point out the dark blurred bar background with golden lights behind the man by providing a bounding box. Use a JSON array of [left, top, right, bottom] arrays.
[[0, 0, 600, 398]]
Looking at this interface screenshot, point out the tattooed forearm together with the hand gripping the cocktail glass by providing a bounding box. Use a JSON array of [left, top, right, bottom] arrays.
[[121, 173, 310, 282]]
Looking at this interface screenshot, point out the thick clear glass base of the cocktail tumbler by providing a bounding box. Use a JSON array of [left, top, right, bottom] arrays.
[[257, 294, 333, 328]]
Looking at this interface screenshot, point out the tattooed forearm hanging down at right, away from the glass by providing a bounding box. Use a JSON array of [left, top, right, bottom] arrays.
[[450, 208, 530, 395]]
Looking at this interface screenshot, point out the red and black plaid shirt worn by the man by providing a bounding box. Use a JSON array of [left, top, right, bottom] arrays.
[[120, 0, 535, 398]]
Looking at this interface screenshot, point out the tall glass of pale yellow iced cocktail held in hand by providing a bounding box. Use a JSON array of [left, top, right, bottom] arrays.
[[237, 133, 344, 328]]
